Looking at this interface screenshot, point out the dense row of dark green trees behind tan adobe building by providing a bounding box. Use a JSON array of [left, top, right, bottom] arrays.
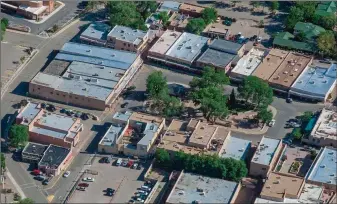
[[154, 149, 248, 182]]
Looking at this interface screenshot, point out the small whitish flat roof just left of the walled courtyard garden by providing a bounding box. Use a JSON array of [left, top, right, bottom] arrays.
[[251, 137, 281, 166]]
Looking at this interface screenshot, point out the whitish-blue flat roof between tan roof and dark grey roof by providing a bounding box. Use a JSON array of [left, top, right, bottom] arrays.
[[166, 33, 209, 62]]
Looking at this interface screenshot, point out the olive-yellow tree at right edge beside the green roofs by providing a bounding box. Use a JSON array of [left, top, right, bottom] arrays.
[[317, 31, 337, 55]]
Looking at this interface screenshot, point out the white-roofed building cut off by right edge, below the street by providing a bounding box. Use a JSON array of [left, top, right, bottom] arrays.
[[302, 109, 337, 148]]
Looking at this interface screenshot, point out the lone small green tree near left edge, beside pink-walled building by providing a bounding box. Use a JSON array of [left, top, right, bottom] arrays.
[[9, 124, 29, 147]]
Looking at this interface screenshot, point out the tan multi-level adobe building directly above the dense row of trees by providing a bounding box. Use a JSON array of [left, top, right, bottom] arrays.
[[157, 119, 230, 155]]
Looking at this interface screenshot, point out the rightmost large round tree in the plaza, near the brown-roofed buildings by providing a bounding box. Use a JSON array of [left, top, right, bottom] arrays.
[[238, 76, 273, 108]]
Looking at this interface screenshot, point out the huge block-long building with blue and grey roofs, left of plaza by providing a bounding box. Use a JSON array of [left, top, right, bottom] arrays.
[[29, 43, 142, 110]]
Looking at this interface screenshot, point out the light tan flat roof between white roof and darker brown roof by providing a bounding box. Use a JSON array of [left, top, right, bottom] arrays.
[[252, 49, 289, 81]]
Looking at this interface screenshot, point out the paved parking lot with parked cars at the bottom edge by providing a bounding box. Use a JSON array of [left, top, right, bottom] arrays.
[[69, 157, 147, 203]]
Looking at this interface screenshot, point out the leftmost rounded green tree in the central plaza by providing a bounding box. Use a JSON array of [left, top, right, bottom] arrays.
[[146, 71, 168, 100]]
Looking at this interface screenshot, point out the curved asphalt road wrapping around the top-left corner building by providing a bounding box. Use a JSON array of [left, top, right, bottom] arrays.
[[0, 0, 81, 34]]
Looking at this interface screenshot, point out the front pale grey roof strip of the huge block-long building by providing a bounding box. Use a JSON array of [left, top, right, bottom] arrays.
[[30, 72, 111, 101]]
